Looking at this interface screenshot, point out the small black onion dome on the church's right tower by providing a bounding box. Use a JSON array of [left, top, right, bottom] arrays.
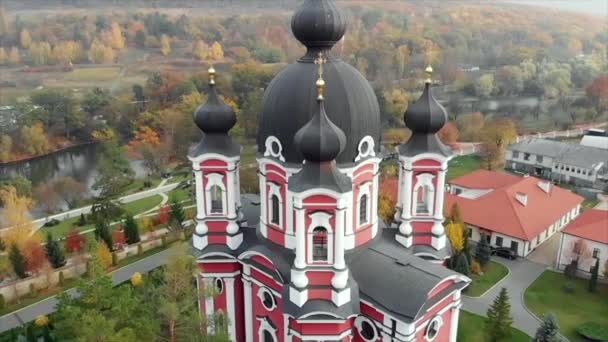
[[404, 82, 448, 134]]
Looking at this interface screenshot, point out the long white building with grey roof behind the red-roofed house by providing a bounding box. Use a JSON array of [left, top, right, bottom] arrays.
[[505, 138, 608, 190]]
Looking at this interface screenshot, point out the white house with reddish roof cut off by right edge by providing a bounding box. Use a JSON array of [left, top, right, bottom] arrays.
[[556, 209, 608, 276]]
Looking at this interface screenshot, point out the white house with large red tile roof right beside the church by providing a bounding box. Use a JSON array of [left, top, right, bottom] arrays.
[[444, 170, 583, 257]]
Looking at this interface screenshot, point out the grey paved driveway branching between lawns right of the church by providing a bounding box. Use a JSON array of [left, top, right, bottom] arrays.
[[462, 258, 546, 336]]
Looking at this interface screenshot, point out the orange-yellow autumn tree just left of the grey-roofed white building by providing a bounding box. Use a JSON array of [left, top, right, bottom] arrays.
[[481, 118, 517, 170]]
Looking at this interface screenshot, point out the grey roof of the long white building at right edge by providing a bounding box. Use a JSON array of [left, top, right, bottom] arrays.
[[509, 138, 608, 168]]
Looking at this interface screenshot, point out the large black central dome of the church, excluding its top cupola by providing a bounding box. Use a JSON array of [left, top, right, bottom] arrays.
[[257, 56, 381, 164]]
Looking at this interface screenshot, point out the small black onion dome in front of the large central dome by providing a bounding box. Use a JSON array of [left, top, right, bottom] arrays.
[[294, 99, 346, 162]]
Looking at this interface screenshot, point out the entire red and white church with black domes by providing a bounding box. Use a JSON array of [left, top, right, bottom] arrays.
[[188, 0, 470, 342]]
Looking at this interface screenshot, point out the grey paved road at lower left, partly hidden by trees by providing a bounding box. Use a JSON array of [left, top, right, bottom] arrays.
[[0, 248, 174, 333]]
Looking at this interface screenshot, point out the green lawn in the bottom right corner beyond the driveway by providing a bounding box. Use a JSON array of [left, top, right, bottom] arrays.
[[525, 271, 608, 342]]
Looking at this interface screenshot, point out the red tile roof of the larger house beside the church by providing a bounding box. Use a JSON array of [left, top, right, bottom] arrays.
[[445, 171, 583, 241]]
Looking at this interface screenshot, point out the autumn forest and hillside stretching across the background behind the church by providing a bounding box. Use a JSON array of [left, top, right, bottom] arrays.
[[0, 1, 608, 170]]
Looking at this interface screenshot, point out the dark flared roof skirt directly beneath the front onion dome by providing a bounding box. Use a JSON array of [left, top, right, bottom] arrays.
[[287, 162, 353, 193]]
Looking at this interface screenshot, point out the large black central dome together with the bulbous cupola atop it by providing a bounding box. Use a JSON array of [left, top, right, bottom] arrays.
[[257, 0, 381, 165]]
